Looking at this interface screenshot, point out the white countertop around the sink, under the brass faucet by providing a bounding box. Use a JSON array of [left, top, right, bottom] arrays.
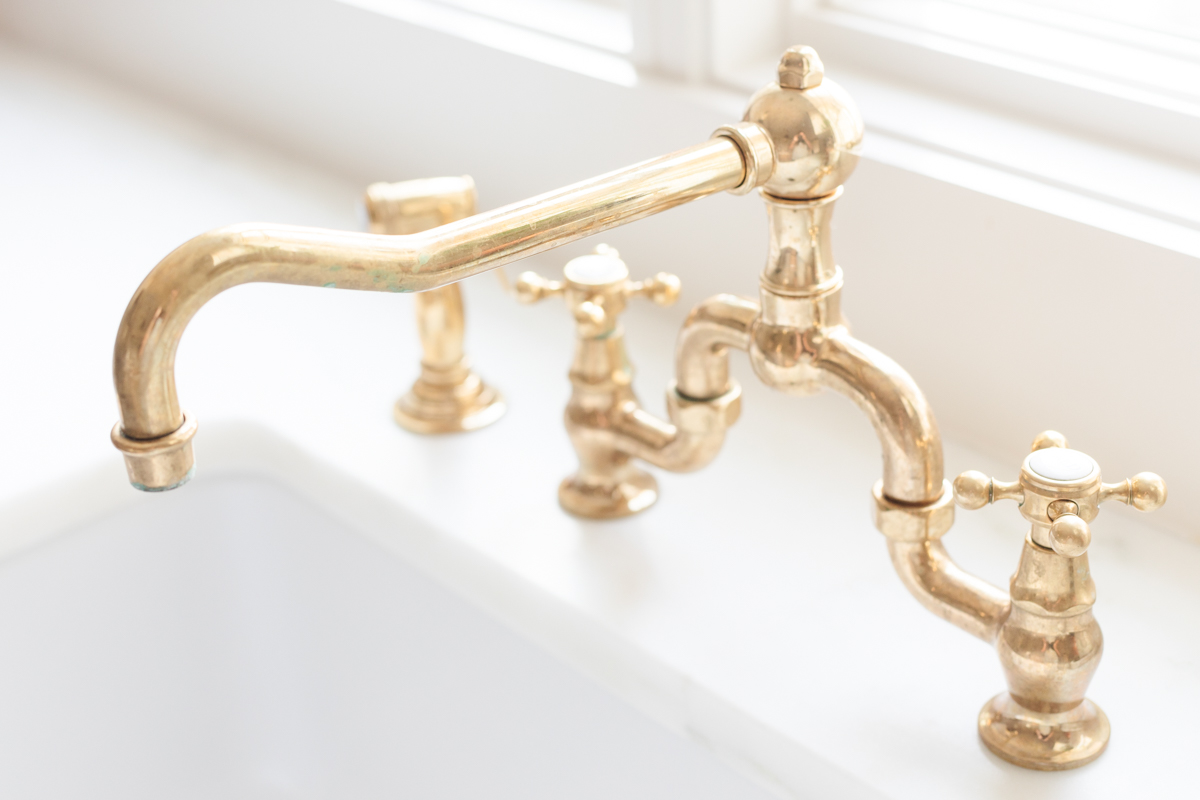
[[0, 37, 1200, 799]]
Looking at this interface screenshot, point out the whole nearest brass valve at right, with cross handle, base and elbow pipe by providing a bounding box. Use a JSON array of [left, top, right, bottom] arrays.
[[907, 431, 1166, 770]]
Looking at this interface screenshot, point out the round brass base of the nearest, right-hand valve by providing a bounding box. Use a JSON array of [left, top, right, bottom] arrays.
[[979, 692, 1111, 770]]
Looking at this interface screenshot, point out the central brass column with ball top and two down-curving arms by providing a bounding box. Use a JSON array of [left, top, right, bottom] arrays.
[[676, 47, 953, 506]]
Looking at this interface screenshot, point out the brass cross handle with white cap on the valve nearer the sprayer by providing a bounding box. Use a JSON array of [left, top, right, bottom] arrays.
[[515, 245, 680, 336]]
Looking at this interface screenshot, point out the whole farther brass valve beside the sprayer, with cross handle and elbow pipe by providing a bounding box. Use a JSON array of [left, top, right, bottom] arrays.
[[516, 245, 742, 519]]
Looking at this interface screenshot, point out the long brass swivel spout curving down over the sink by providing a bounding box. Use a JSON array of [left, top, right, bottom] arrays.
[[113, 133, 772, 489]]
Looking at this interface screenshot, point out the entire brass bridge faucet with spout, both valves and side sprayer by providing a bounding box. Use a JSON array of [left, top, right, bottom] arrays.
[[113, 47, 1165, 770]]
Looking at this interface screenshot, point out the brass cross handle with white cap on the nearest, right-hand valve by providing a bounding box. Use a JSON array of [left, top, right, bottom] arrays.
[[954, 431, 1166, 558]]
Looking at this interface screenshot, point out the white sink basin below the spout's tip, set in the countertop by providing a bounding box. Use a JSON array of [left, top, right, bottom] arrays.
[[0, 475, 768, 800]]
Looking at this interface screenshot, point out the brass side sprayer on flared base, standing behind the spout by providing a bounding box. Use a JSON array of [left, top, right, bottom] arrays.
[[366, 175, 504, 433]]
